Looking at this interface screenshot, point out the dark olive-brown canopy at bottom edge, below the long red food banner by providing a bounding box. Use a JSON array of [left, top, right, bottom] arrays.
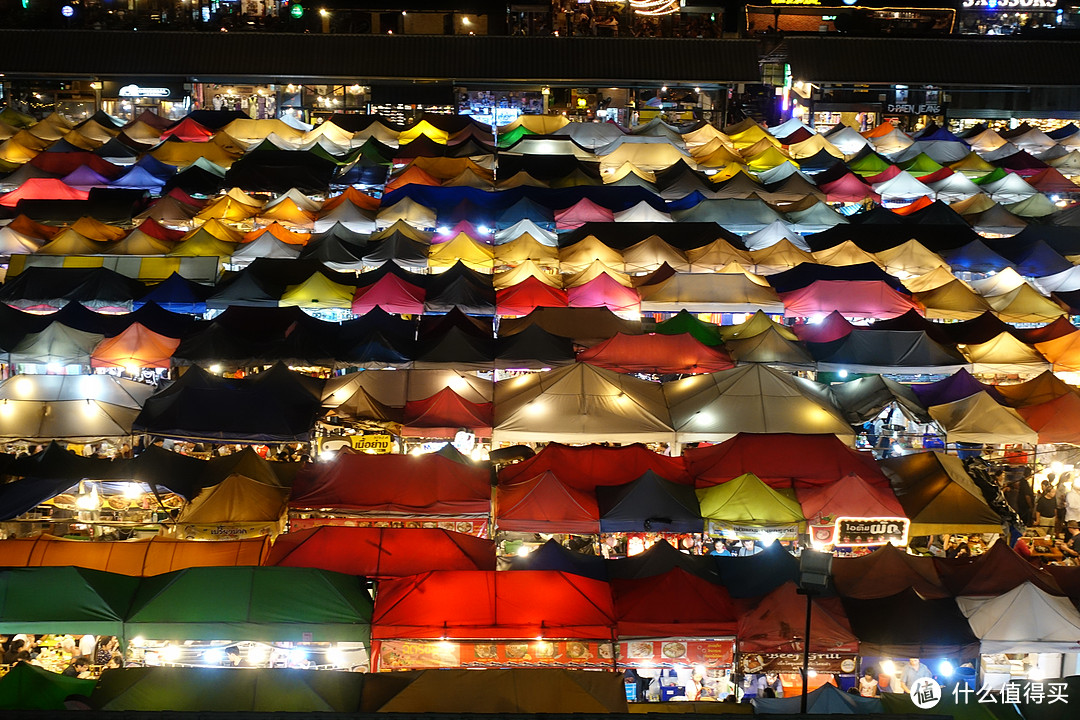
[[364, 667, 626, 715]]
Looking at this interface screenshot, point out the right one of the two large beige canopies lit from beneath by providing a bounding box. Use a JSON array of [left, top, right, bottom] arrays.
[[663, 365, 854, 443]]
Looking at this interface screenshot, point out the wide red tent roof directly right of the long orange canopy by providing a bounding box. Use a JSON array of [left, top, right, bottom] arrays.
[[264, 526, 495, 579]]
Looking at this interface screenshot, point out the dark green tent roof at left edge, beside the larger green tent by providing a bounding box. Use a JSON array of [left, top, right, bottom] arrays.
[[0, 568, 139, 636]]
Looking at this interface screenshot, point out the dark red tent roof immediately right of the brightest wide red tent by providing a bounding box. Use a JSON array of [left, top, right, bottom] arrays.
[[611, 568, 738, 638]]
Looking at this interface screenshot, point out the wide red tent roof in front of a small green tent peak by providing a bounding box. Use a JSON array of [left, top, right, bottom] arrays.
[[578, 332, 734, 373]]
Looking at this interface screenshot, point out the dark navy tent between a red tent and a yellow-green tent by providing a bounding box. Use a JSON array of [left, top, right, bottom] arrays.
[[596, 471, 702, 532]]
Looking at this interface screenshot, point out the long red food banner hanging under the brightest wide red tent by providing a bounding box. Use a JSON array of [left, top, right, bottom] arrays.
[[375, 640, 615, 670]]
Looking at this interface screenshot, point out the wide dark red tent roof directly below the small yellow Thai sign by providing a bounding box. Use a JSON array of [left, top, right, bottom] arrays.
[[289, 454, 491, 517]]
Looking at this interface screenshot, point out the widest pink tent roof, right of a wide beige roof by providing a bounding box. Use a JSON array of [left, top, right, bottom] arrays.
[[778, 280, 922, 320]]
